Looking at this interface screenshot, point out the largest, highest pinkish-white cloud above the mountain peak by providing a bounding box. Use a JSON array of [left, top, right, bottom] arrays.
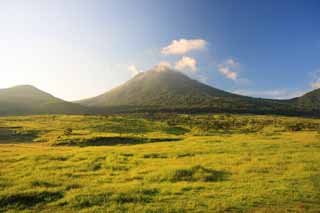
[[161, 39, 207, 55]]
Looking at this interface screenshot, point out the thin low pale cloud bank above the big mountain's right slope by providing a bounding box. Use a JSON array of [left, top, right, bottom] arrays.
[[233, 89, 305, 99]]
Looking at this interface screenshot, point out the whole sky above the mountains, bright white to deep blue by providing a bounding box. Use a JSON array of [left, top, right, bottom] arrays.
[[0, 0, 320, 100]]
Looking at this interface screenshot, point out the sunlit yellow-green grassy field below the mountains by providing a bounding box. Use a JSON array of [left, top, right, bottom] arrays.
[[0, 114, 320, 212]]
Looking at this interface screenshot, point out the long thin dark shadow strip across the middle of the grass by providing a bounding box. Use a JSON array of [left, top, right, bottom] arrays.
[[53, 137, 181, 147]]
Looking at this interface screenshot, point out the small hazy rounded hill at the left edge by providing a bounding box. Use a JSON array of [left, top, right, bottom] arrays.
[[0, 85, 88, 115]]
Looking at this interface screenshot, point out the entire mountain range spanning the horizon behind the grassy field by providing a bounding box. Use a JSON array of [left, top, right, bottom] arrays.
[[0, 68, 320, 116]]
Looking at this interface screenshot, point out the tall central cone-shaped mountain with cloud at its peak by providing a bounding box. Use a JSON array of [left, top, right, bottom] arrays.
[[77, 67, 299, 114]]
